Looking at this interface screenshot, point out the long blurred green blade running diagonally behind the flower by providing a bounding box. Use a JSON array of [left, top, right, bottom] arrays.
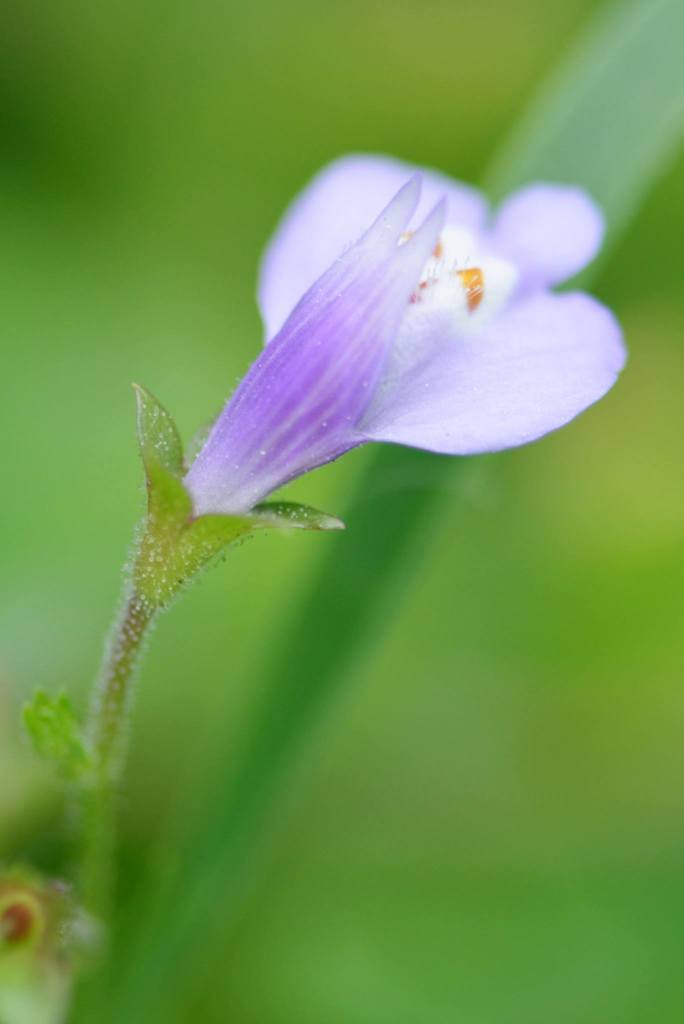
[[74, 0, 684, 1024]]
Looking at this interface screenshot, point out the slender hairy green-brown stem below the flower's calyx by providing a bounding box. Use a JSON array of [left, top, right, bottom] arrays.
[[80, 591, 156, 924]]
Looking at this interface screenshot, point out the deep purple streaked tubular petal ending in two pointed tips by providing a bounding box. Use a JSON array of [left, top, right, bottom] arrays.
[[185, 176, 444, 515]]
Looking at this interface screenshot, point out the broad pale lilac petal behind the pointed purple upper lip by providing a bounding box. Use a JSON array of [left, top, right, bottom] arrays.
[[258, 156, 486, 340]]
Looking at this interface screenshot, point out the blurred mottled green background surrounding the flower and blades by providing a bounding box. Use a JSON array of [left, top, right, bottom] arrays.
[[0, 0, 684, 1024]]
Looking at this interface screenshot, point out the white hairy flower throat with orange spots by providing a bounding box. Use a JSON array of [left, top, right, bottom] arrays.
[[399, 225, 518, 333]]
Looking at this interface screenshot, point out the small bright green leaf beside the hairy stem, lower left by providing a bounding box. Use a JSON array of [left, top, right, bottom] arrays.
[[24, 690, 90, 778]]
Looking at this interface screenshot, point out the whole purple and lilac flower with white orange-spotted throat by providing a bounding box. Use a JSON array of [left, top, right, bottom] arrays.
[[185, 157, 625, 514]]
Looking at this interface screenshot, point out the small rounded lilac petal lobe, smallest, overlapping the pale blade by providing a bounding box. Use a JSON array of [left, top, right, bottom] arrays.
[[490, 184, 604, 288]]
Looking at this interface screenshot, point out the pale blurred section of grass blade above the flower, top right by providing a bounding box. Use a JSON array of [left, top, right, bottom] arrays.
[[486, 0, 684, 234]]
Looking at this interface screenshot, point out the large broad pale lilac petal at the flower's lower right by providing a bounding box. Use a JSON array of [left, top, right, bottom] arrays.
[[359, 292, 625, 455]]
